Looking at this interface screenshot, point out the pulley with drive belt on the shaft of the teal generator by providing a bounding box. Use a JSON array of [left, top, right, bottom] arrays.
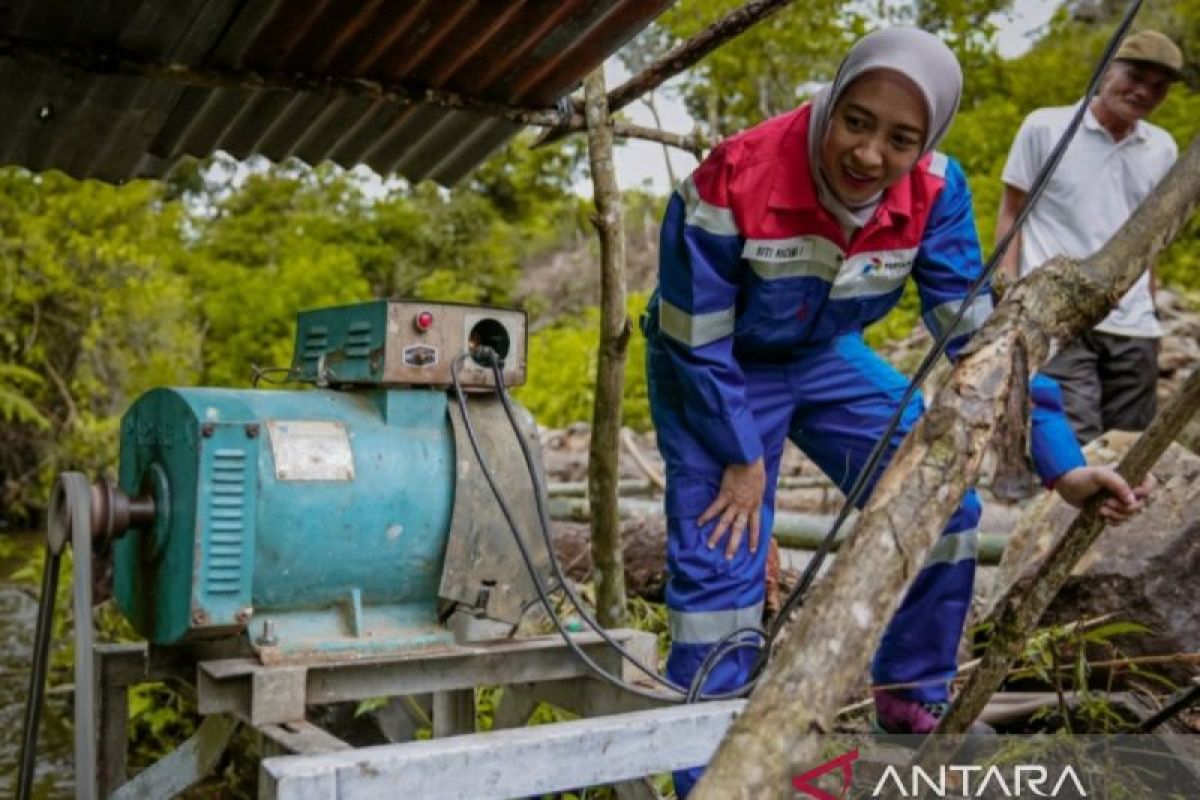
[[17, 473, 155, 800]]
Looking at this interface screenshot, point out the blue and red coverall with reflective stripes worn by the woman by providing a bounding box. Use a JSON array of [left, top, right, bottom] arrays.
[[643, 106, 1084, 792]]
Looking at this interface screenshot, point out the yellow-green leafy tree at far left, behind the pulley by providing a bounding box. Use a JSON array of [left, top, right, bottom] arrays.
[[0, 169, 198, 517]]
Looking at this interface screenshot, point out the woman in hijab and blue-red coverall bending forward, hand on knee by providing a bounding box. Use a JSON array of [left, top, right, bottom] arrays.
[[642, 28, 1146, 796]]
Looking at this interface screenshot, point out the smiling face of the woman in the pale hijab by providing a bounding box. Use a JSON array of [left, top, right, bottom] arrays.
[[821, 70, 929, 206]]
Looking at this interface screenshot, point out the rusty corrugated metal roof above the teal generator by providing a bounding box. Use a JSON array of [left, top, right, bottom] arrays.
[[0, 0, 671, 185]]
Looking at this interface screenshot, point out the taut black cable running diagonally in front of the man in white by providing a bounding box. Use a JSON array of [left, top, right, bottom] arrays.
[[700, 0, 1142, 686]]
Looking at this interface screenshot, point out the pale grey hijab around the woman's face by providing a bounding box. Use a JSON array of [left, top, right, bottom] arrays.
[[809, 26, 962, 236]]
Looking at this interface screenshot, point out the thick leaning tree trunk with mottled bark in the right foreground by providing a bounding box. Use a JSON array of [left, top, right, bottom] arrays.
[[694, 140, 1200, 800]]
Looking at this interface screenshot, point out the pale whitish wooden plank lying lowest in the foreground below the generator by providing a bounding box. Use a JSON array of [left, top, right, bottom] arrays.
[[259, 700, 745, 800]]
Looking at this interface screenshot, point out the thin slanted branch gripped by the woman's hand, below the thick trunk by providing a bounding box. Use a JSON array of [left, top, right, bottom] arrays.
[[917, 369, 1200, 765]]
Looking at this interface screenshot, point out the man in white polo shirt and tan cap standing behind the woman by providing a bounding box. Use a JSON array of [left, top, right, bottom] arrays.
[[996, 30, 1183, 444]]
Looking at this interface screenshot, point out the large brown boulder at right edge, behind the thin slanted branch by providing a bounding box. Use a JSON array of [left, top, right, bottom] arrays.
[[986, 432, 1200, 681]]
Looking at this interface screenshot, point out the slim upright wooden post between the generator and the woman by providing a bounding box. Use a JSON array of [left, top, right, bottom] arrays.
[[583, 66, 630, 627]]
